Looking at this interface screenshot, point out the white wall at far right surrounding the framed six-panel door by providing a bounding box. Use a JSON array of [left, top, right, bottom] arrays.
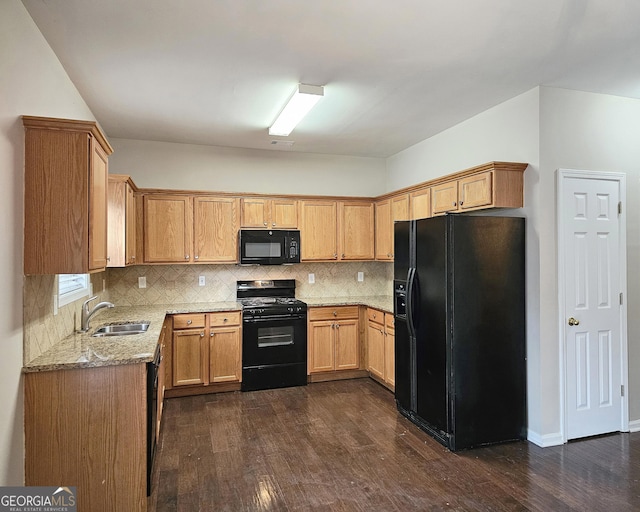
[[539, 88, 640, 432]]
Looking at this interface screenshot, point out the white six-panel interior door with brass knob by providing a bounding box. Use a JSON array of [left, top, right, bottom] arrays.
[[558, 172, 626, 440]]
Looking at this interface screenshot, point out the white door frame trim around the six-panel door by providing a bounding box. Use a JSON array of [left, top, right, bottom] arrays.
[[556, 169, 629, 443]]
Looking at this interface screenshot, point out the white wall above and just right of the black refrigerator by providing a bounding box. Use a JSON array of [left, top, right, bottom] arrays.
[[387, 88, 546, 439]]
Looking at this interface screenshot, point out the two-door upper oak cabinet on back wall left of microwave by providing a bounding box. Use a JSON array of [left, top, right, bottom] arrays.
[[143, 193, 240, 263]]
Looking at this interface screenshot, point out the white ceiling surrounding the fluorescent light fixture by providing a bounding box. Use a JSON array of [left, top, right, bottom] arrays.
[[23, 0, 640, 157]]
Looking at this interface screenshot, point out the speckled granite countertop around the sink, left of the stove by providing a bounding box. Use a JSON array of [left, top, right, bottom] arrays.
[[22, 301, 242, 373]]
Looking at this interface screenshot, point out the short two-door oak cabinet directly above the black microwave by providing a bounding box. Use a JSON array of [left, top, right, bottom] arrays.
[[241, 197, 298, 229]]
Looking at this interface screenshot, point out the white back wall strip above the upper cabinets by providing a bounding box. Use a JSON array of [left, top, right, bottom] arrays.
[[109, 137, 385, 196]]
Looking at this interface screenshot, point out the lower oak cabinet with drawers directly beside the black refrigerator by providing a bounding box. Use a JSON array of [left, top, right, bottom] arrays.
[[367, 308, 395, 389]]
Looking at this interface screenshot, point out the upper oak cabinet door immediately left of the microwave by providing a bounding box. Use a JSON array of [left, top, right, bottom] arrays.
[[193, 197, 239, 263]]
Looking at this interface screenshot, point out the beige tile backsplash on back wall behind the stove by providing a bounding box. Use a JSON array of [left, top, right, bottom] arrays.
[[109, 261, 393, 306]]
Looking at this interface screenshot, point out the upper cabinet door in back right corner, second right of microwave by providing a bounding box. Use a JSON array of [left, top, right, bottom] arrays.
[[340, 202, 375, 260]]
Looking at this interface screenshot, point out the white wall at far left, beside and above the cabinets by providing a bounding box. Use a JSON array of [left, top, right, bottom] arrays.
[[0, 0, 94, 485]]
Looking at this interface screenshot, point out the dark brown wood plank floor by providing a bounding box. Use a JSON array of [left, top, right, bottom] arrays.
[[149, 379, 640, 512]]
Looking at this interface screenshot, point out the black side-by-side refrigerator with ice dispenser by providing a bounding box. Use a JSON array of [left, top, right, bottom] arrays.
[[394, 214, 526, 451]]
